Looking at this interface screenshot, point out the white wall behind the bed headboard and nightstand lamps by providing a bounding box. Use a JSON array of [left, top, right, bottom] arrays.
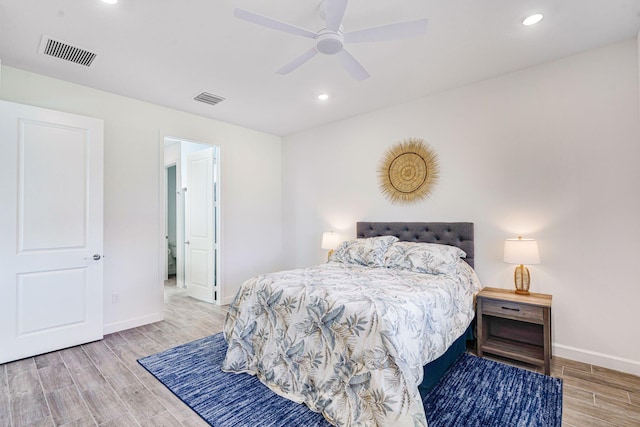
[[282, 40, 640, 374]]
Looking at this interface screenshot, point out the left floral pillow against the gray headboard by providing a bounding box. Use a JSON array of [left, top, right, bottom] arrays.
[[329, 236, 398, 267]]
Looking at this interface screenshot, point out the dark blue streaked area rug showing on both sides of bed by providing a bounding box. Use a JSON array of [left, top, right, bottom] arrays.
[[138, 334, 562, 427]]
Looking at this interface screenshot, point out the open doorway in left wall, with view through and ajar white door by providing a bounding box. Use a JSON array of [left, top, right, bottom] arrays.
[[161, 137, 220, 304]]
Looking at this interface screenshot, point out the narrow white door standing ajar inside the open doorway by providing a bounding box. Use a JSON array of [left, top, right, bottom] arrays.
[[185, 148, 216, 303]]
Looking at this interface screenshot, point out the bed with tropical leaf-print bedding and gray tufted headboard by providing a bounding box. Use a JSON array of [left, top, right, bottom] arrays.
[[223, 222, 481, 426]]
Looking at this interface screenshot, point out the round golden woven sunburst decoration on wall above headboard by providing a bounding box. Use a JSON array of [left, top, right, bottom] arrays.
[[378, 138, 440, 204]]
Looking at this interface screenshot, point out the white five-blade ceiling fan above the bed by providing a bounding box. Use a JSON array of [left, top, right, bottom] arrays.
[[233, 0, 427, 81]]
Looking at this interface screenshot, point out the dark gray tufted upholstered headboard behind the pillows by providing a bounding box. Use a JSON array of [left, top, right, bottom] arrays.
[[356, 222, 474, 267]]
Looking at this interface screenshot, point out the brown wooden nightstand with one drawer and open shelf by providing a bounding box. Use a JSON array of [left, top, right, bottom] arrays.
[[477, 288, 552, 375]]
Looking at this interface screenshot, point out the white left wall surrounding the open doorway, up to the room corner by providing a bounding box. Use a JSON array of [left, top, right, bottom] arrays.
[[0, 66, 282, 333]]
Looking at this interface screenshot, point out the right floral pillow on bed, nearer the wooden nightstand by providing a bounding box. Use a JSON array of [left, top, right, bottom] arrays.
[[384, 242, 467, 274]]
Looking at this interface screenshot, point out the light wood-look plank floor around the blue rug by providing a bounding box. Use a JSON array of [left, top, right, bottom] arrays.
[[0, 282, 640, 427]]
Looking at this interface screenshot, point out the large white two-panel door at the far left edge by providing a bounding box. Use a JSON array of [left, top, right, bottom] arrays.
[[0, 101, 103, 363]]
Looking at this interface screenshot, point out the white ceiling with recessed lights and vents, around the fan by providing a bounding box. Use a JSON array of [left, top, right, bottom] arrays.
[[0, 0, 640, 135]]
